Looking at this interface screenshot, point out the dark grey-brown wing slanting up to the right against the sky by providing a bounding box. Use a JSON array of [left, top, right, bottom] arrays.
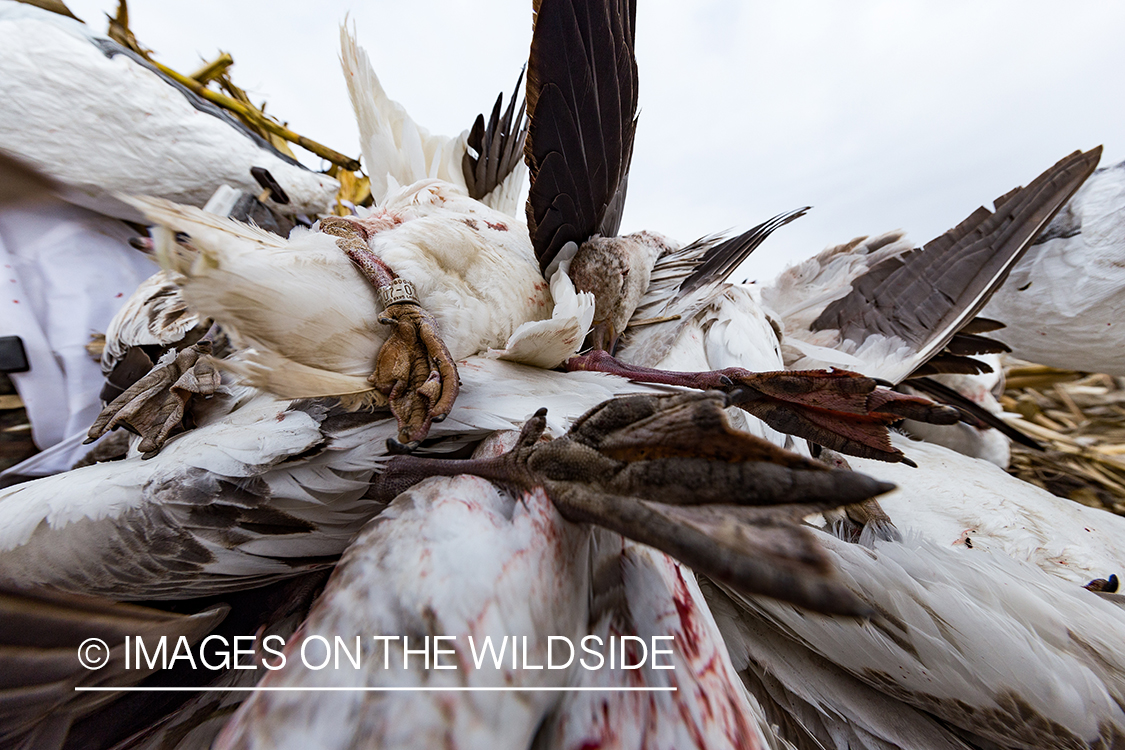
[[811, 146, 1101, 352]]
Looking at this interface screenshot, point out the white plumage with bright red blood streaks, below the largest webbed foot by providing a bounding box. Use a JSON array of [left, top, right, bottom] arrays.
[[537, 531, 772, 750]]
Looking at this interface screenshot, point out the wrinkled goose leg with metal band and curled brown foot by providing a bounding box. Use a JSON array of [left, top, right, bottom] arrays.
[[321, 217, 460, 450]]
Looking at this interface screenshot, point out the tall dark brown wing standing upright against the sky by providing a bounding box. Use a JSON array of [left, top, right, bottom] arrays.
[[524, 0, 637, 270]]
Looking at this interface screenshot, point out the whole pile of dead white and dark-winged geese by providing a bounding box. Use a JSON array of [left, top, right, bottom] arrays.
[[0, 0, 1125, 749]]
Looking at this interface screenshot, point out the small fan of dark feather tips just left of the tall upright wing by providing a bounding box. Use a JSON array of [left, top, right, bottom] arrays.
[[461, 71, 528, 200]]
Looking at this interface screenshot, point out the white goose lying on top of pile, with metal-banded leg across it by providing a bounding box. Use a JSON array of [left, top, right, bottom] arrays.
[[91, 180, 592, 448]]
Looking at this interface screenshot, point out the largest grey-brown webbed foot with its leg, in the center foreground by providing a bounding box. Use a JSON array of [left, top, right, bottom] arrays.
[[376, 391, 893, 615]]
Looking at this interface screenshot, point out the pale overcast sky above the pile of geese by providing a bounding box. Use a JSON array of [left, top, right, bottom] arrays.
[[68, 0, 1125, 279]]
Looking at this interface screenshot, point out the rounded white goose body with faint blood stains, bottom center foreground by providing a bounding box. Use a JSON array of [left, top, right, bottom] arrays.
[[215, 433, 591, 750]]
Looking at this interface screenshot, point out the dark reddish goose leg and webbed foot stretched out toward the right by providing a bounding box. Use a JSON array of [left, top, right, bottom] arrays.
[[566, 351, 960, 466]]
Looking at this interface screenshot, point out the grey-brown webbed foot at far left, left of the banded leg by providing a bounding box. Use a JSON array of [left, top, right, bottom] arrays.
[[84, 340, 222, 459]]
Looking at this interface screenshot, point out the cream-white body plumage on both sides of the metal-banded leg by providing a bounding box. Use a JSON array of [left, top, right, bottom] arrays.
[[136, 180, 593, 398]]
